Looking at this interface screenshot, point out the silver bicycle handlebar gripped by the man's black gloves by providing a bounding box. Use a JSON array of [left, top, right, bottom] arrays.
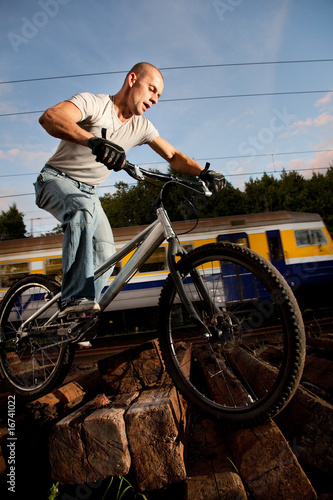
[[123, 160, 213, 197]]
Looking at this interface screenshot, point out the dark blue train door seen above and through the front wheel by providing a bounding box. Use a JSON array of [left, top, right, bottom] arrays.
[[217, 233, 258, 302]]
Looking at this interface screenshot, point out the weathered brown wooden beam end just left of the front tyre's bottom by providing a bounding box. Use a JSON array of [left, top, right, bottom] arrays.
[[125, 386, 186, 491]]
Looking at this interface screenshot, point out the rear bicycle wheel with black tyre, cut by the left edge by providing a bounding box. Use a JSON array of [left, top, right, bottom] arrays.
[[0, 275, 74, 400]]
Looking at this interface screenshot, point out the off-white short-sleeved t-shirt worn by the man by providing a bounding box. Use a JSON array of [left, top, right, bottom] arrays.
[[47, 92, 159, 186]]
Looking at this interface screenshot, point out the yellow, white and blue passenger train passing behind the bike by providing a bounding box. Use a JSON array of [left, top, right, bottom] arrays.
[[0, 211, 333, 326]]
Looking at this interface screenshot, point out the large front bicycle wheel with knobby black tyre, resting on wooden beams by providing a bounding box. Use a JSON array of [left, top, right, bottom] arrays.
[[160, 243, 305, 426]]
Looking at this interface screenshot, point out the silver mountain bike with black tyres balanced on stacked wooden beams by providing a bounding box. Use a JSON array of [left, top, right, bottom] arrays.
[[0, 162, 305, 426]]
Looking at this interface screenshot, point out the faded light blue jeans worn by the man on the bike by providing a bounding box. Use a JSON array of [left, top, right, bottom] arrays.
[[34, 165, 115, 305]]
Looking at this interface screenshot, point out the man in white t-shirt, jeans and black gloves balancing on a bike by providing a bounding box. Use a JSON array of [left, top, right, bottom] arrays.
[[35, 63, 224, 316]]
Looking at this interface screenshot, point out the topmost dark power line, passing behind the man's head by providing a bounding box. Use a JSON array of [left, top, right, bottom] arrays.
[[0, 59, 333, 85]]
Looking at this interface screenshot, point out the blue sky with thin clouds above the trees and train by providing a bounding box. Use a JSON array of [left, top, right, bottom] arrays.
[[0, 0, 333, 236]]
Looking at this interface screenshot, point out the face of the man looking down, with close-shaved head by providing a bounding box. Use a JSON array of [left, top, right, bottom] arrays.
[[128, 68, 164, 115]]
